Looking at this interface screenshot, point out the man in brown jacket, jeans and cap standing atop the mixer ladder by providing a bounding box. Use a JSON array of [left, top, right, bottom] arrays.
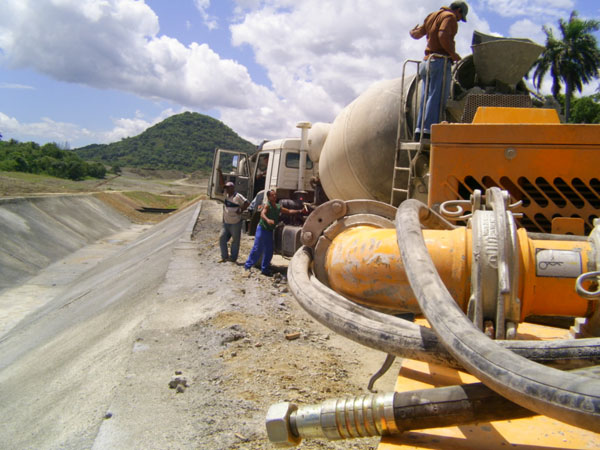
[[410, 0, 469, 141]]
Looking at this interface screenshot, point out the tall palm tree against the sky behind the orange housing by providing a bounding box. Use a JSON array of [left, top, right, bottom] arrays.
[[533, 11, 600, 121]]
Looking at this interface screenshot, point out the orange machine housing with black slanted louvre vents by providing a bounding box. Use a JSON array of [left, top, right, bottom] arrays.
[[428, 107, 600, 234]]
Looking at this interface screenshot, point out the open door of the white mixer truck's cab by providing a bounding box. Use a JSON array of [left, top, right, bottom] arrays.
[[208, 148, 249, 201]]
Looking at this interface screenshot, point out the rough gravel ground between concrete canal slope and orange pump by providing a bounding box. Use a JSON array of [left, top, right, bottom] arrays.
[[183, 202, 393, 449]]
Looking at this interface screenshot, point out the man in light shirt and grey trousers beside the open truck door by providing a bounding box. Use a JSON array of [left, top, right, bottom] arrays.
[[219, 181, 248, 262]]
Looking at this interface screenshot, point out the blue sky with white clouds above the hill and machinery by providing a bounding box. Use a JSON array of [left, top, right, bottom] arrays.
[[0, 0, 600, 148]]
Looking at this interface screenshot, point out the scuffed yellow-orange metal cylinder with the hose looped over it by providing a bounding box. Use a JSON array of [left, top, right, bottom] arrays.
[[325, 226, 594, 321]]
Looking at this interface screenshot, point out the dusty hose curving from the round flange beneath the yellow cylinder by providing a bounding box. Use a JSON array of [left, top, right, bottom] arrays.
[[288, 247, 600, 369]]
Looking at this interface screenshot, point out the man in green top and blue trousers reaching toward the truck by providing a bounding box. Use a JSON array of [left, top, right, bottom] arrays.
[[244, 189, 302, 277]]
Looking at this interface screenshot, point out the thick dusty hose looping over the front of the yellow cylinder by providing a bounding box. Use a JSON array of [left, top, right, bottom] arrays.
[[396, 200, 600, 432]]
